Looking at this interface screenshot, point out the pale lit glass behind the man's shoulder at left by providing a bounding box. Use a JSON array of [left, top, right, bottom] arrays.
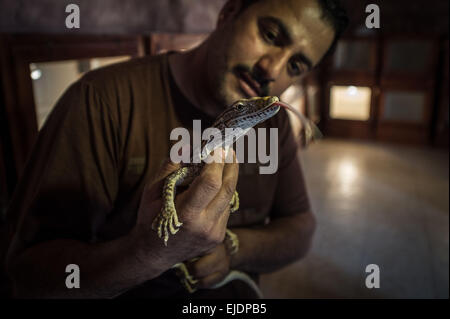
[[30, 56, 130, 129]]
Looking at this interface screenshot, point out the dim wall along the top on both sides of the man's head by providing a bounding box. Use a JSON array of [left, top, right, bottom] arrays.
[[0, 0, 449, 34]]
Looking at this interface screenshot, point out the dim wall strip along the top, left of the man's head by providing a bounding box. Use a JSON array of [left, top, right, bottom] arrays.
[[0, 0, 225, 34]]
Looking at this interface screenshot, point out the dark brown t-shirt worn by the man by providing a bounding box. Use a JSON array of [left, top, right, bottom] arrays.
[[7, 55, 309, 297]]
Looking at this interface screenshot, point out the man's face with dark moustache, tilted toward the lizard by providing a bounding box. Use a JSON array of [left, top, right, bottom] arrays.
[[207, 0, 334, 105]]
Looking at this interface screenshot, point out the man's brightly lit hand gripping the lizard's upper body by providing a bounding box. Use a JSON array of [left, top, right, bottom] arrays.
[[133, 149, 239, 269]]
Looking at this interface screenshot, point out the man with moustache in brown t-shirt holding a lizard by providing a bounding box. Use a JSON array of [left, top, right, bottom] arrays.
[[3, 0, 343, 297]]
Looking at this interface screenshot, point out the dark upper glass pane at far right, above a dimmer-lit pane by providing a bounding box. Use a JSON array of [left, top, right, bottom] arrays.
[[387, 40, 432, 73]]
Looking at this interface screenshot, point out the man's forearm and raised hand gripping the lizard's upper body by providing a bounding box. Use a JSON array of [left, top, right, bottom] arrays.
[[7, 149, 238, 298]]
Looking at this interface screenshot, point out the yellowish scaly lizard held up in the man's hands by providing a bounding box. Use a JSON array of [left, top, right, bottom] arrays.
[[152, 96, 281, 294]]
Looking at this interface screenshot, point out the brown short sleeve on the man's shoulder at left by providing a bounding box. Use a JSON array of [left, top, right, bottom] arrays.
[[7, 80, 120, 258]]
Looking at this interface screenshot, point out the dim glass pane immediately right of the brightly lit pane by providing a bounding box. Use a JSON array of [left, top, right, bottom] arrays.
[[383, 91, 425, 122]]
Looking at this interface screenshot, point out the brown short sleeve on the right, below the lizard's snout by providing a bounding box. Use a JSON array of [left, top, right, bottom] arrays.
[[271, 110, 310, 217]]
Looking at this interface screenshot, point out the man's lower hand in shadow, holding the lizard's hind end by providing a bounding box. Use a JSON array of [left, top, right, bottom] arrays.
[[186, 243, 231, 289]]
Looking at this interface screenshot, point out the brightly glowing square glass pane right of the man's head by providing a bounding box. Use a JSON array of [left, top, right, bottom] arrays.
[[330, 86, 372, 121]]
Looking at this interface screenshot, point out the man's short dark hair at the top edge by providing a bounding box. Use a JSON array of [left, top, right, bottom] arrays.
[[241, 0, 348, 59]]
